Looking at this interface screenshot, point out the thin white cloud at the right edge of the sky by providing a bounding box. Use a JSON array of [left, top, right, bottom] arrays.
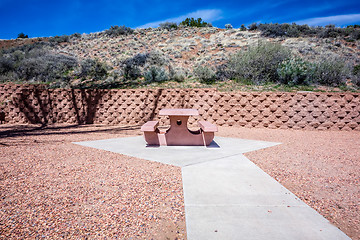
[[296, 14, 360, 26]]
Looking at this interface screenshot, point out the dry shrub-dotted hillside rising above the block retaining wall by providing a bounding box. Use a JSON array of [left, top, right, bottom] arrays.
[[0, 27, 360, 90]]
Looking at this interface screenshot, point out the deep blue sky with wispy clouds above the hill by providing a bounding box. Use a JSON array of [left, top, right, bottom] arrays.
[[0, 0, 360, 39]]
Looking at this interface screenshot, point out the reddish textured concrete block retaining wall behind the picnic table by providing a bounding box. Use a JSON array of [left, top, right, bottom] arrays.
[[0, 84, 360, 130]]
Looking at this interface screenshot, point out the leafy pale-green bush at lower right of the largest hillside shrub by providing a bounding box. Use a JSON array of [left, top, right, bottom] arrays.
[[277, 57, 315, 85]]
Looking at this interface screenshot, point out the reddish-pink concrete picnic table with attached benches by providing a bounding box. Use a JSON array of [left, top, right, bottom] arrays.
[[141, 109, 217, 146]]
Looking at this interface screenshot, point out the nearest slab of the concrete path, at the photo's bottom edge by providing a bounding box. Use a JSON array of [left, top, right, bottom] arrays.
[[186, 205, 350, 240]]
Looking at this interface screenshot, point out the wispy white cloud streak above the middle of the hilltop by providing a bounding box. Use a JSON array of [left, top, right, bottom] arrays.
[[138, 9, 222, 28]]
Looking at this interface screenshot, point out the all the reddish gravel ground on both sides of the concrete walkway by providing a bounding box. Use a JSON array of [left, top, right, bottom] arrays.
[[0, 125, 360, 240]]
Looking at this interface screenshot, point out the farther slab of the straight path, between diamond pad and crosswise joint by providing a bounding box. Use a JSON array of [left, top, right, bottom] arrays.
[[182, 155, 306, 206]]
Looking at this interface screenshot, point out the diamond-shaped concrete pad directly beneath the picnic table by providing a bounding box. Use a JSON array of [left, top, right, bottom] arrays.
[[75, 136, 280, 167]]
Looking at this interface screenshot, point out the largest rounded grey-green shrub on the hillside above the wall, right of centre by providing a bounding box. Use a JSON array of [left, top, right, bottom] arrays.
[[228, 42, 291, 84]]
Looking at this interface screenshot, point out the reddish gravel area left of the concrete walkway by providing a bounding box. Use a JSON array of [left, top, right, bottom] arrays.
[[0, 125, 186, 239]]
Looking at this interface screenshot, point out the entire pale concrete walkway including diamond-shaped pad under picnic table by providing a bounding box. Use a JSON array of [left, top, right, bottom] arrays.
[[76, 136, 350, 240]]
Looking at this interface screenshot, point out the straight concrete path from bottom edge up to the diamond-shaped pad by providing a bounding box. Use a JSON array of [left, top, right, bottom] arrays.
[[182, 155, 349, 240]]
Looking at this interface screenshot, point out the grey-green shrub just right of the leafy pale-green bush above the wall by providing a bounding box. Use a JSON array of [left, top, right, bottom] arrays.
[[314, 56, 349, 86]]
